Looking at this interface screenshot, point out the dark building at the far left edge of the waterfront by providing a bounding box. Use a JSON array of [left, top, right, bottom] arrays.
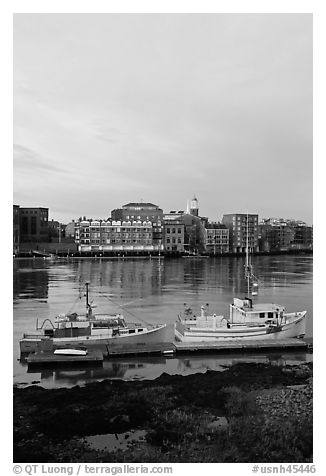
[[19, 207, 49, 243]]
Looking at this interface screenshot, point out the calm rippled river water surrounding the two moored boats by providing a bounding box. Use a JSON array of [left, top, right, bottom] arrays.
[[13, 255, 313, 388]]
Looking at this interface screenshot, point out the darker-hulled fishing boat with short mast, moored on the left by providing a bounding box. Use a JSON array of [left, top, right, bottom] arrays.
[[19, 283, 166, 354]]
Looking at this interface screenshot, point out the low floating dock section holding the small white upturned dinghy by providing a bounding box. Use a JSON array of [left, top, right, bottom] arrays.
[[26, 350, 103, 366]]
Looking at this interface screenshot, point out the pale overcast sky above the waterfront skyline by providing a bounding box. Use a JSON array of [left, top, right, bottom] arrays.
[[14, 13, 312, 224]]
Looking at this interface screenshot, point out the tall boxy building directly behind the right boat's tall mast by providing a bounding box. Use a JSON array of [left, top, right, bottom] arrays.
[[222, 213, 259, 253]]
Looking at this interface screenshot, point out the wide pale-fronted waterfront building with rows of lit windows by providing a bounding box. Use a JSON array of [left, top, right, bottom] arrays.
[[75, 219, 163, 253]]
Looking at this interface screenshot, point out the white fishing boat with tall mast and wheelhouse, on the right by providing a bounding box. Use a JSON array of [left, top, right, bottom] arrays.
[[175, 217, 307, 342]]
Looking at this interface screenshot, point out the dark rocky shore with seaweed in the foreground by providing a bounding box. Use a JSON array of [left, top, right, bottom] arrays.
[[14, 363, 313, 463]]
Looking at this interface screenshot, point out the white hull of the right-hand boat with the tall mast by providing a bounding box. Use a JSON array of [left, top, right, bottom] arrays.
[[175, 311, 306, 342]]
